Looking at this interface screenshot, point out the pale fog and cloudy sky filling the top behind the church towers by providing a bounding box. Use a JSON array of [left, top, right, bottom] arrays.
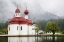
[[0, 0, 64, 21]]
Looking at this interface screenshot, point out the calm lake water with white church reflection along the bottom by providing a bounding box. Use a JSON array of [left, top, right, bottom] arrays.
[[0, 37, 64, 42]]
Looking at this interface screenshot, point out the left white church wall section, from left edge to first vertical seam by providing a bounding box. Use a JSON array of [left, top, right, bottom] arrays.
[[8, 24, 19, 35]]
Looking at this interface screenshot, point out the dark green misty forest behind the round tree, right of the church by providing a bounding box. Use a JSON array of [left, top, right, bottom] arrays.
[[36, 18, 64, 31]]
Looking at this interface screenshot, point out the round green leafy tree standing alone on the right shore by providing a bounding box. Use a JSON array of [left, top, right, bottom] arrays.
[[45, 22, 60, 35]]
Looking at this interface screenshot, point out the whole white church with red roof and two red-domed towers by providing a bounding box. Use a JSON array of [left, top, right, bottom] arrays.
[[8, 8, 35, 35]]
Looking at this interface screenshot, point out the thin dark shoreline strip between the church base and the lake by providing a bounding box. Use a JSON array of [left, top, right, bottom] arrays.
[[0, 34, 64, 37]]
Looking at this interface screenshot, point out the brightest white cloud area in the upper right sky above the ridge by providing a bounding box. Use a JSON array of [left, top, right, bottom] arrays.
[[38, 0, 64, 16]]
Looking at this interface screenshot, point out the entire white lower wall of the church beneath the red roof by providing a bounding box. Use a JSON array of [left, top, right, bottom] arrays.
[[8, 24, 35, 35]]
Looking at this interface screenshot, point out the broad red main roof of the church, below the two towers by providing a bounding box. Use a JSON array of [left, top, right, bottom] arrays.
[[9, 17, 32, 24]]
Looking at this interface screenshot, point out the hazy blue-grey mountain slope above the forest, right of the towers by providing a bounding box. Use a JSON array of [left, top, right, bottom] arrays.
[[30, 12, 60, 21]]
